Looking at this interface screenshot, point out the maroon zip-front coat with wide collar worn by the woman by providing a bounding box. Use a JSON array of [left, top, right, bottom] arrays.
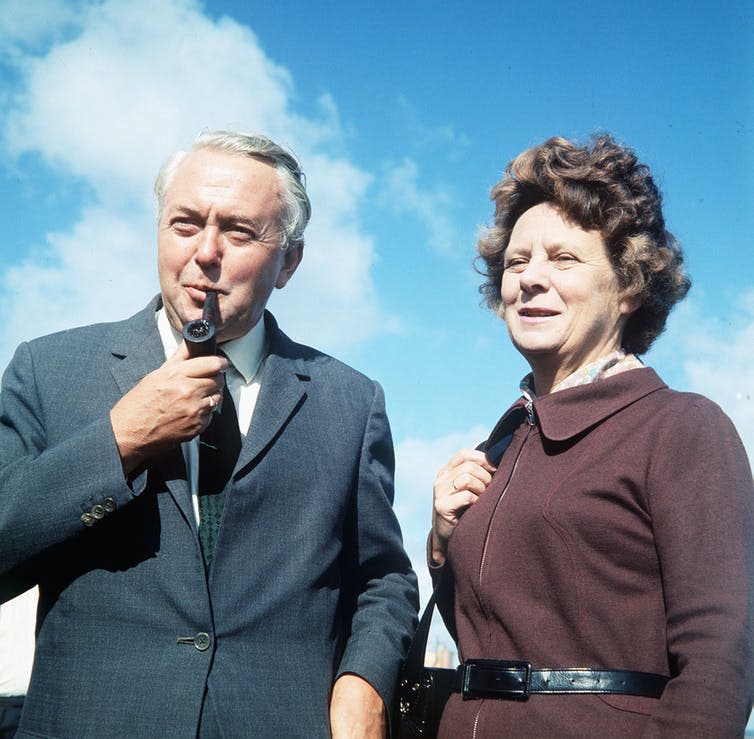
[[433, 368, 754, 739]]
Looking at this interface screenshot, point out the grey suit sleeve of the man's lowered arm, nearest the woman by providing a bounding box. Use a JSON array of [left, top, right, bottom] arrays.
[[337, 383, 418, 708]]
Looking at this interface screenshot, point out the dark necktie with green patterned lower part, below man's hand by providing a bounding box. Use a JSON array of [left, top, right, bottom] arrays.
[[198, 385, 241, 570]]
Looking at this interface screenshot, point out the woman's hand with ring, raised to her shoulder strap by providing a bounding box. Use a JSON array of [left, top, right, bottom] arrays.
[[432, 449, 495, 565]]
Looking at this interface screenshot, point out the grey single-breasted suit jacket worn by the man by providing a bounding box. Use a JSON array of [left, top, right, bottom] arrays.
[[0, 298, 417, 738]]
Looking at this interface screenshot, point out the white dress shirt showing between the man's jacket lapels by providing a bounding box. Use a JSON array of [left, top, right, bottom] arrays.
[[156, 308, 267, 525]]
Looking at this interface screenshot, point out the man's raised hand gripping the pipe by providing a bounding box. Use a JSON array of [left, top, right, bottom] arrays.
[[110, 342, 228, 474]]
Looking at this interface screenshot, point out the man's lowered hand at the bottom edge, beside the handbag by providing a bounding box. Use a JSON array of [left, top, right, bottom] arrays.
[[330, 674, 387, 739]]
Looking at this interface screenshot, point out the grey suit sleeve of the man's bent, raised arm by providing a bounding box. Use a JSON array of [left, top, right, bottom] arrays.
[[0, 344, 133, 601]]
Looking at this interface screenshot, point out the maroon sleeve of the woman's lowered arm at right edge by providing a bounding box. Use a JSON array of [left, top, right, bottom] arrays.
[[645, 396, 754, 739]]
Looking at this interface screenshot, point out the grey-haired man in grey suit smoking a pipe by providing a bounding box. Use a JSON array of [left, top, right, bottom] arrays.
[[0, 132, 417, 739]]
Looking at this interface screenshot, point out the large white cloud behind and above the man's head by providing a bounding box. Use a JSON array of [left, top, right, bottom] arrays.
[[0, 0, 394, 368]]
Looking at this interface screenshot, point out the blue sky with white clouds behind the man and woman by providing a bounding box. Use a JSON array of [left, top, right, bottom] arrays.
[[0, 0, 754, 704]]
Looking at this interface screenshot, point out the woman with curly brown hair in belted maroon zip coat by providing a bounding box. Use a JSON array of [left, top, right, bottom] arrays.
[[430, 136, 754, 739]]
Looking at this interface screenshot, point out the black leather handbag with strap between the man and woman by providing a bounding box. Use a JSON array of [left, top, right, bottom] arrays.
[[393, 589, 456, 739]]
